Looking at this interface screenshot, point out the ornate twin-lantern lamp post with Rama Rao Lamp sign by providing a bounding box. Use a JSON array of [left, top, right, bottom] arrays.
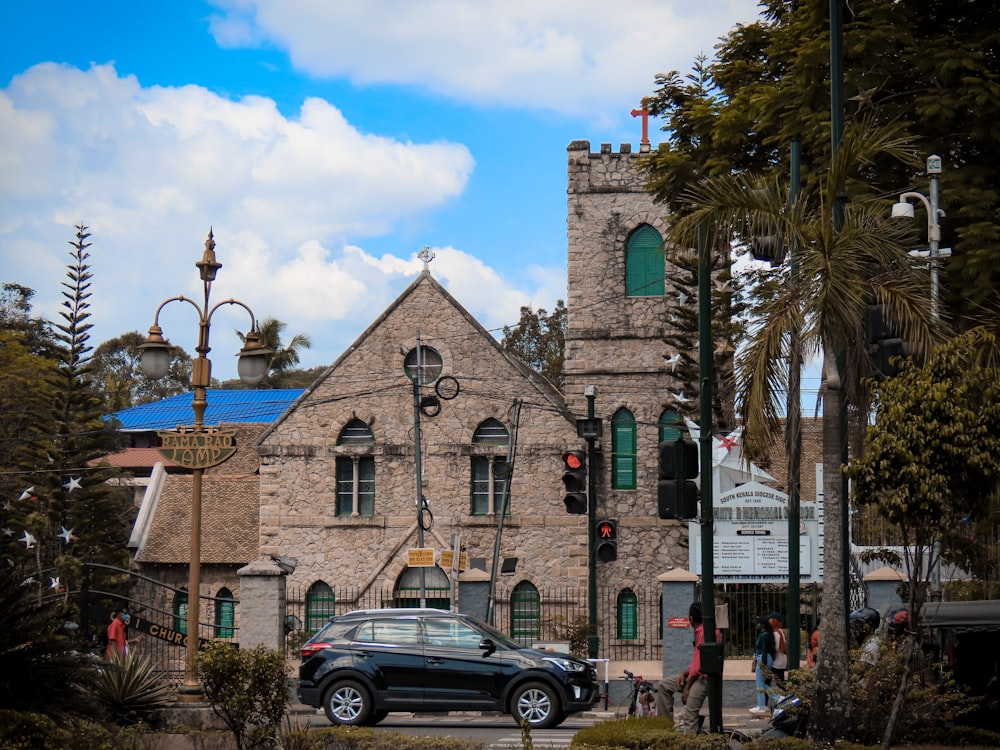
[[139, 230, 273, 700]]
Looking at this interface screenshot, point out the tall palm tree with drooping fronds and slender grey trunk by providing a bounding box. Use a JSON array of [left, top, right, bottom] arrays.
[[668, 123, 943, 739]]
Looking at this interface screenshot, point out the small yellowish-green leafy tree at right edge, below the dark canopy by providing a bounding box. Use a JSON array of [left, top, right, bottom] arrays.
[[847, 328, 1000, 592]]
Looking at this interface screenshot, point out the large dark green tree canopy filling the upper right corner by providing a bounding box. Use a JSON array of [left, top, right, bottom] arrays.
[[648, 0, 1000, 328]]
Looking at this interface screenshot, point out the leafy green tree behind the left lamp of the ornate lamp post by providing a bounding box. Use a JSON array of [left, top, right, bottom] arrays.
[[92, 331, 191, 414]]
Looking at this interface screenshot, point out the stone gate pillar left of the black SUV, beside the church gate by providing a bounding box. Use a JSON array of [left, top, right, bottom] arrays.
[[236, 560, 287, 653]]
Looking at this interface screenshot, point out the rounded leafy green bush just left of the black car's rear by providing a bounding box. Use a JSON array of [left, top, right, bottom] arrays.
[[198, 641, 288, 750]]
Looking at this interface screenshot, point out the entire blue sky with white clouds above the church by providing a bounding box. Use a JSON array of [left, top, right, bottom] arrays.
[[0, 0, 758, 378]]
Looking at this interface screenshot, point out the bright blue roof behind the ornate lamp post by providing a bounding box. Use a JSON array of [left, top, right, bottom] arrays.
[[112, 388, 305, 432]]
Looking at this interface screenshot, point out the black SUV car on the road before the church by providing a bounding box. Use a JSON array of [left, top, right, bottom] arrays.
[[297, 609, 599, 728]]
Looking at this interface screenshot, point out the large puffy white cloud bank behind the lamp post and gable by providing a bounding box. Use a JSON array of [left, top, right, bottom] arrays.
[[0, 63, 572, 377]]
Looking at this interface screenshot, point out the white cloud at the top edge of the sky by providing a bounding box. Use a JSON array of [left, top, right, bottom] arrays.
[[212, 0, 758, 119]]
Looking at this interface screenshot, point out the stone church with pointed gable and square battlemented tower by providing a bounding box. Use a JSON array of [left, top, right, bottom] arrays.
[[250, 141, 700, 642]]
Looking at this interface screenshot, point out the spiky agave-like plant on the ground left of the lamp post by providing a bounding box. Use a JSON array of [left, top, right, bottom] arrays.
[[89, 653, 174, 726]]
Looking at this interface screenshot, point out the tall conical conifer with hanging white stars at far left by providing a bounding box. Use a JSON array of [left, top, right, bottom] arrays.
[[4, 225, 131, 597]]
